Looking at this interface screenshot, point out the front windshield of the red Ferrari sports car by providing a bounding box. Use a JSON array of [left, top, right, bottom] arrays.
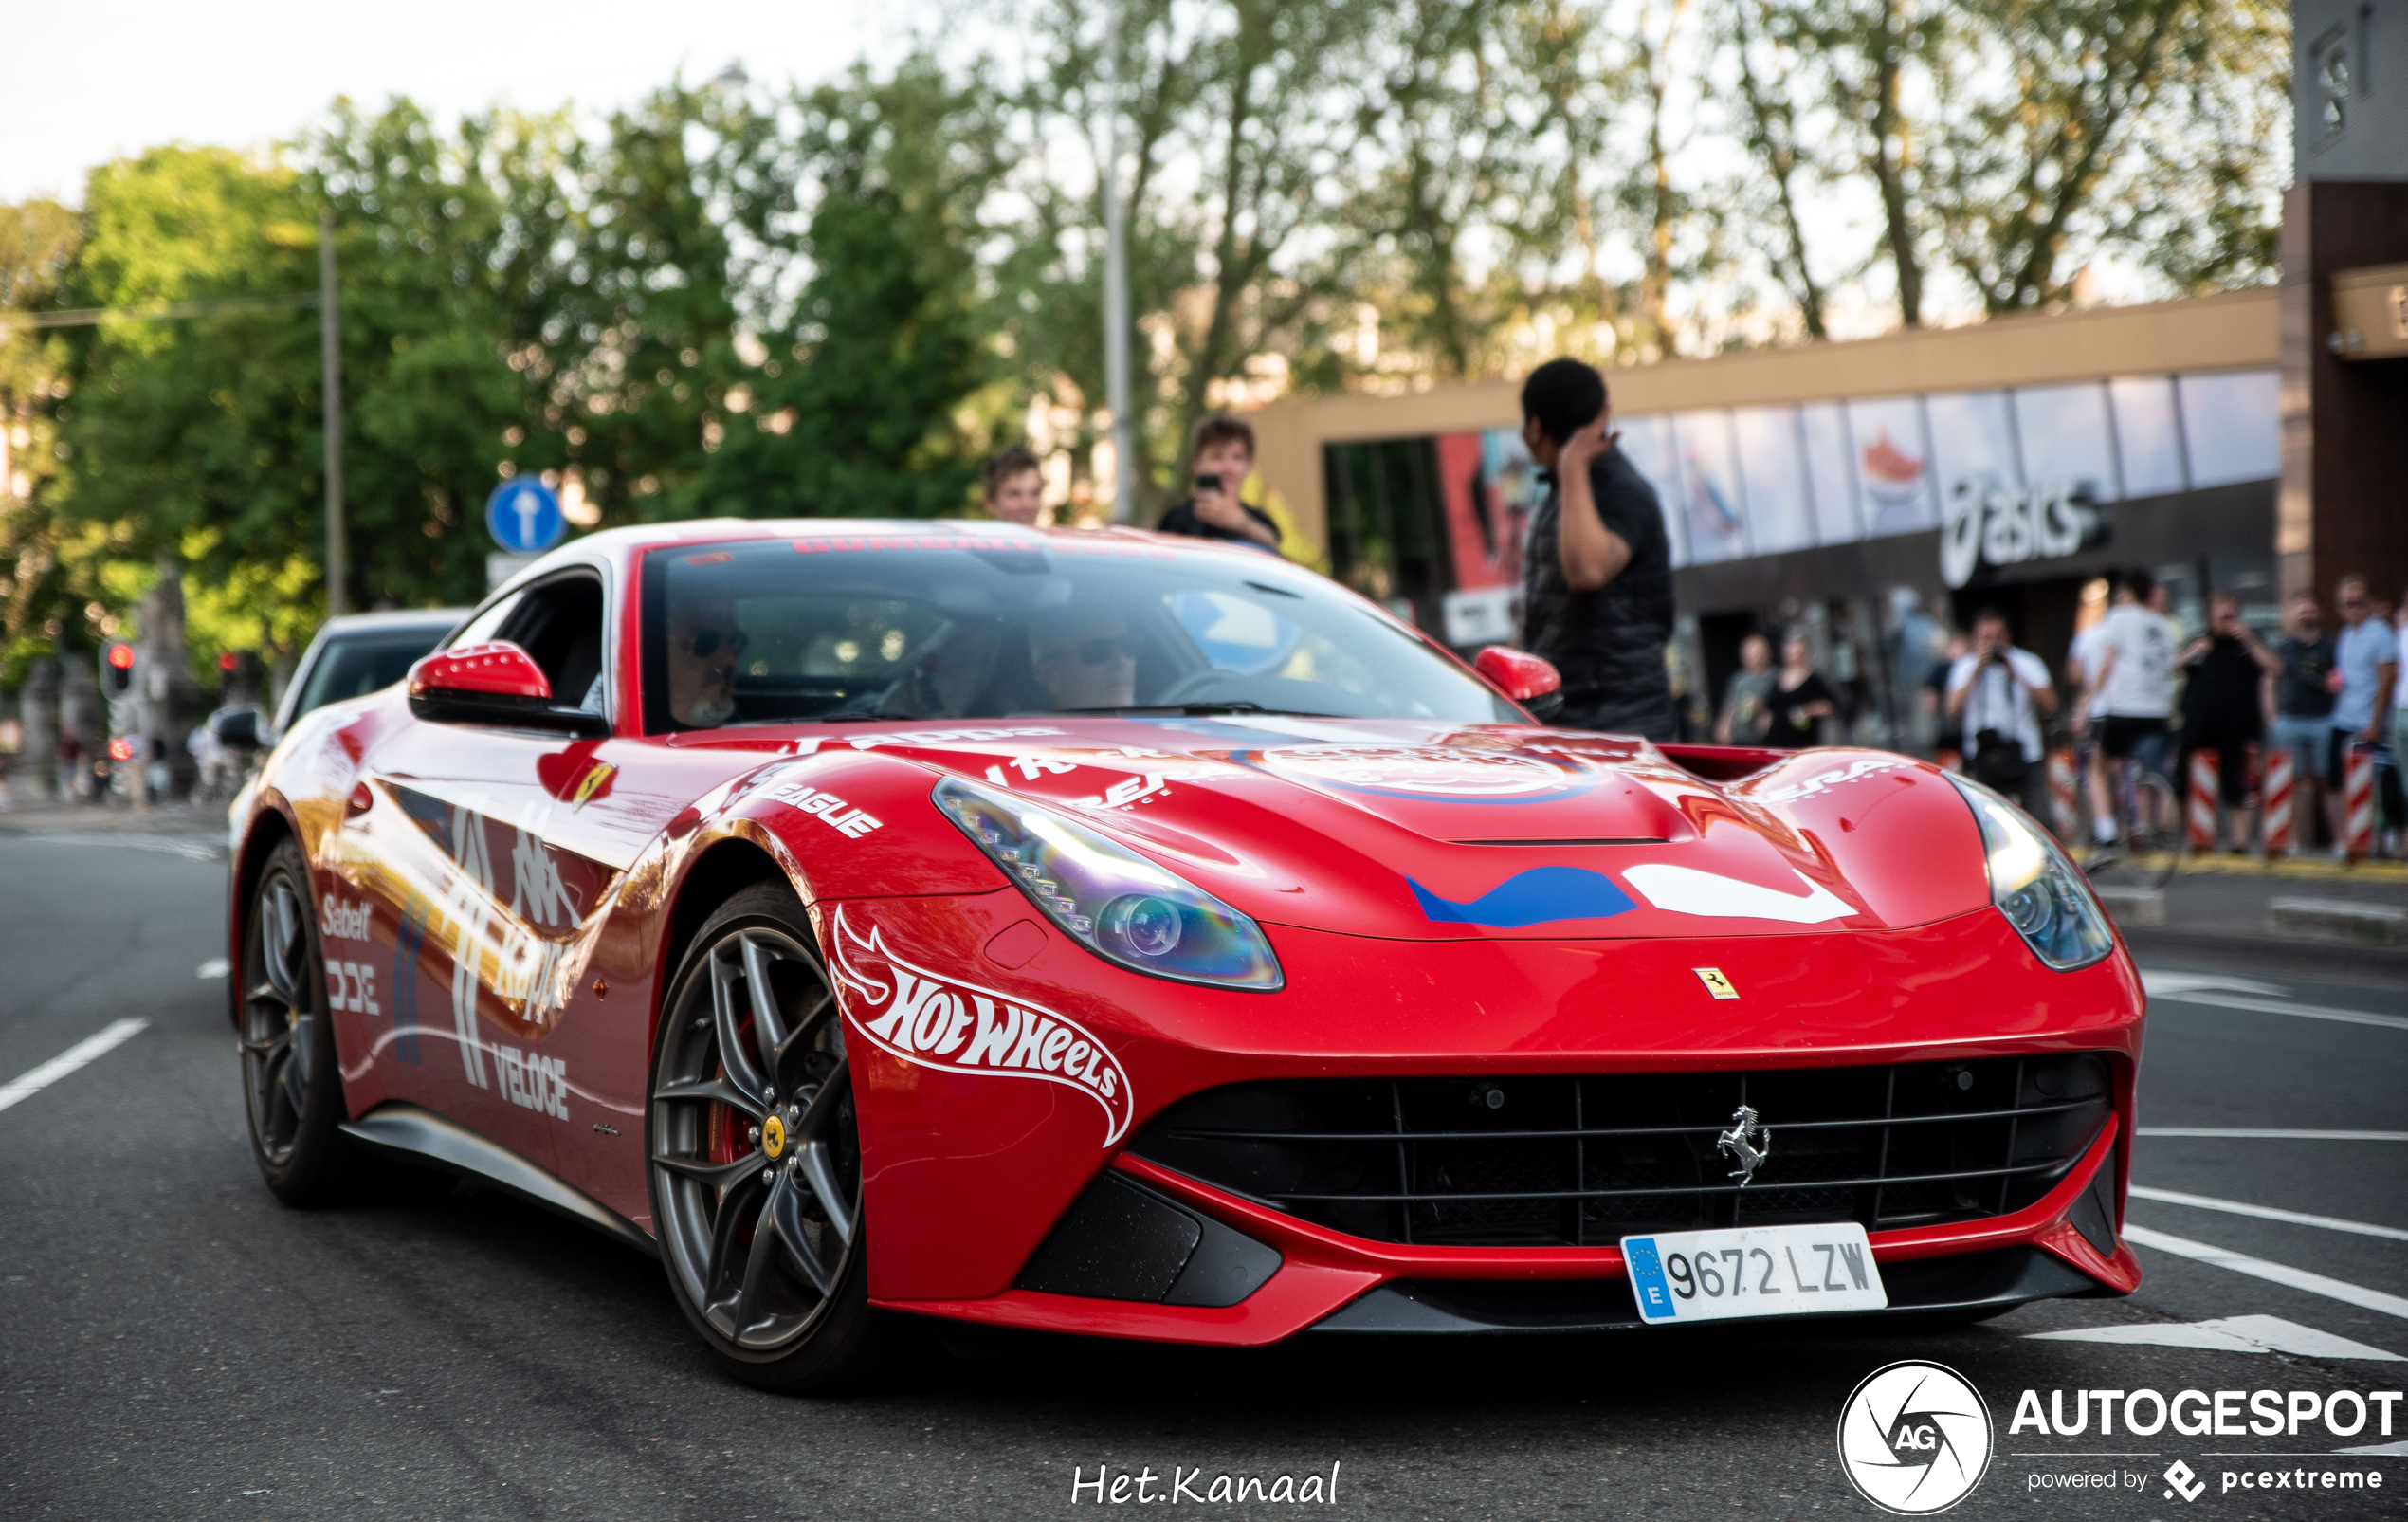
[[643, 532, 1522, 732]]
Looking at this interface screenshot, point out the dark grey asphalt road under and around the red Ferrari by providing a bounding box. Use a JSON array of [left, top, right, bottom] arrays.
[[0, 838, 2408, 1517]]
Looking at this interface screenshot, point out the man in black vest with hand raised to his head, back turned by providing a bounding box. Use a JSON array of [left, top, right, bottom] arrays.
[[1522, 358, 1673, 740]]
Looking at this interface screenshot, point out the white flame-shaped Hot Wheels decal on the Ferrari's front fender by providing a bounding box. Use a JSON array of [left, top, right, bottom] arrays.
[[830, 906, 1132, 1146]]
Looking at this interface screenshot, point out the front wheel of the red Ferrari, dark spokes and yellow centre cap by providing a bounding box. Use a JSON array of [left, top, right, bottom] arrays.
[[646, 884, 871, 1392]]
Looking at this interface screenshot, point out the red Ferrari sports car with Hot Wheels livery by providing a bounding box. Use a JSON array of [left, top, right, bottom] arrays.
[[228, 521, 2143, 1389]]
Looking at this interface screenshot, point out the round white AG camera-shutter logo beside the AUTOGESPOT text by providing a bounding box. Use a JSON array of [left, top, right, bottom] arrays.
[[1840, 1358, 1994, 1517]]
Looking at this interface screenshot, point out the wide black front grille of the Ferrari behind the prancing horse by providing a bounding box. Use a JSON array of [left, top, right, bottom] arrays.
[[1132, 1053, 2109, 1247]]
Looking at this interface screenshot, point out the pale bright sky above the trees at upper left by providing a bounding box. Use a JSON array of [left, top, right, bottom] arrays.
[[0, 0, 905, 202]]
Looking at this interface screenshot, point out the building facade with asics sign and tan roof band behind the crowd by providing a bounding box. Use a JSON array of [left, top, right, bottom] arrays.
[[1254, 289, 2283, 744]]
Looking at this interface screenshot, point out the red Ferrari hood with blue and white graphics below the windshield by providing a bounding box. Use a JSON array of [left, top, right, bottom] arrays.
[[797, 715, 1989, 939]]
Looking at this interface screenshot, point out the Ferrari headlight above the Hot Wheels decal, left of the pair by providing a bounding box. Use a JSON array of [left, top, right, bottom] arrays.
[[932, 778, 1286, 990]]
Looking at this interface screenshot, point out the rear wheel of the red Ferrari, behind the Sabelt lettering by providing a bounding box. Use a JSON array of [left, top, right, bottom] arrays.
[[241, 840, 352, 1204]]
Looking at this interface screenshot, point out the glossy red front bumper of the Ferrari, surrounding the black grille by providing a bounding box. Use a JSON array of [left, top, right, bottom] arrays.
[[855, 891, 2141, 1347]]
